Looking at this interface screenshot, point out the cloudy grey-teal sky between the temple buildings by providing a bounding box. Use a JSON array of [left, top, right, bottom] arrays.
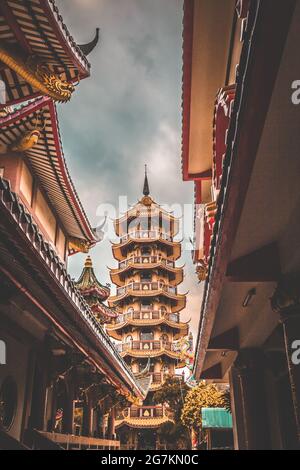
[[57, 0, 200, 333]]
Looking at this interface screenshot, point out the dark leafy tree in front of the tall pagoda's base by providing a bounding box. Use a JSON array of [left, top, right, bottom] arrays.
[[153, 377, 190, 449]]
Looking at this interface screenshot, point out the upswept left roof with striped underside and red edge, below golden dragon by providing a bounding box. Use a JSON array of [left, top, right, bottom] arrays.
[[0, 97, 99, 252]]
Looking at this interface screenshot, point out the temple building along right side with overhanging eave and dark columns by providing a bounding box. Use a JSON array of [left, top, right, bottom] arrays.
[[182, 0, 300, 449]]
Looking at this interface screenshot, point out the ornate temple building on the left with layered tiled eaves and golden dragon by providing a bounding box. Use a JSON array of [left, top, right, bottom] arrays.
[[0, 0, 146, 449]]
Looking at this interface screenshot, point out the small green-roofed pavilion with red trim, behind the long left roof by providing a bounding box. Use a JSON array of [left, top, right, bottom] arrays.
[[75, 256, 117, 324]]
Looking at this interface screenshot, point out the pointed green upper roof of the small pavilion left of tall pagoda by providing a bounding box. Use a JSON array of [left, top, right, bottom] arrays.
[[75, 256, 110, 302]]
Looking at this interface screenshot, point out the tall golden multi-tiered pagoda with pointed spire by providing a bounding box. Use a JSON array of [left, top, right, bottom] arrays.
[[107, 174, 188, 449]]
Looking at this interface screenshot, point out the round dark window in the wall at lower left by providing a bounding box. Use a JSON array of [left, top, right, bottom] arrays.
[[0, 377, 18, 431]]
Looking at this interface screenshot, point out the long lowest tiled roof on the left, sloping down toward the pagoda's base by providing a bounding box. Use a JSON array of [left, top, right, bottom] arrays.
[[0, 177, 146, 401]]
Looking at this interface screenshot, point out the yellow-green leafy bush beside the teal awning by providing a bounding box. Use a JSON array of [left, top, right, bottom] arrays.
[[181, 382, 225, 431]]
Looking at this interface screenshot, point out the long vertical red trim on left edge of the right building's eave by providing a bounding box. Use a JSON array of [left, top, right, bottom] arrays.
[[181, 0, 194, 181]]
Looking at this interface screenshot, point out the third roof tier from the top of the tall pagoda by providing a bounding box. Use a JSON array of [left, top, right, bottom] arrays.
[[110, 261, 183, 287]]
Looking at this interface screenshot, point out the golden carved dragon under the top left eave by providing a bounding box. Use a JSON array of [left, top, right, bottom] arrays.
[[0, 46, 75, 102]]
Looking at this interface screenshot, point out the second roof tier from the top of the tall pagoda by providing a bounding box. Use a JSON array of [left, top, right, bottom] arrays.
[[112, 233, 181, 261]]
